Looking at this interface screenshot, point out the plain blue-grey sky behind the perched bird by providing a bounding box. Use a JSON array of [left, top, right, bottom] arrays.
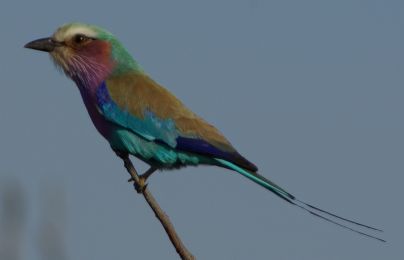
[[0, 0, 404, 260]]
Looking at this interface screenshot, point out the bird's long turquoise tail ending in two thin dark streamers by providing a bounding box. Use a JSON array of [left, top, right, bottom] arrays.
[[216, 159, 386, 242]]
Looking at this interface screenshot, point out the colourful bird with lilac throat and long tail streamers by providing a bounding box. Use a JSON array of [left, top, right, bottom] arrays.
[[24, 22, 385, 242]]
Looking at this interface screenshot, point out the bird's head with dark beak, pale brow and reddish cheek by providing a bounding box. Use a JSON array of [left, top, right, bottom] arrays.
[[24, 23, 141, 87]]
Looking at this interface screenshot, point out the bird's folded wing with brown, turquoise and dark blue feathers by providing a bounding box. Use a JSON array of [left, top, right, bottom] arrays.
[[97, 73, 257, 172]]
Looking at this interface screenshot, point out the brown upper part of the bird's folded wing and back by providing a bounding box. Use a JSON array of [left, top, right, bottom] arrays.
[[106, 73, 257, 171]]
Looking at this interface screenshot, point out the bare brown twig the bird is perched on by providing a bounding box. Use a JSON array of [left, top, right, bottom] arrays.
[[117, 152, 195, 260]]
